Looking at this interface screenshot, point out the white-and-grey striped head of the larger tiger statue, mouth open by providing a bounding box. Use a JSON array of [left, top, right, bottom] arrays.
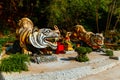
[[29, 28, 59, 49]]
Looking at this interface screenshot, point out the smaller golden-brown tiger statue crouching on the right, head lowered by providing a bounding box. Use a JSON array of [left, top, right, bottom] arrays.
[[71, 25, 104, 49]]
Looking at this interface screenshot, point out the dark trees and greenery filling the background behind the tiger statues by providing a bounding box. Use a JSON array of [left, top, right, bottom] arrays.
[[0, 0, 120, 34]]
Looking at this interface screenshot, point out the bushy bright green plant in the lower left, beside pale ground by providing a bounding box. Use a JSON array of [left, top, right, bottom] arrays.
[[0, 53, 29, 72]]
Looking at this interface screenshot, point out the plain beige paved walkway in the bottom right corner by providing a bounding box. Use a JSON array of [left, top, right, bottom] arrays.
[[77, 64, 120, 80]]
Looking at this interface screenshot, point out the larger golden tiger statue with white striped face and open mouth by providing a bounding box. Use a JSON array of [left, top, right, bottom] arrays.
[[16, 17, 60, 53]]
